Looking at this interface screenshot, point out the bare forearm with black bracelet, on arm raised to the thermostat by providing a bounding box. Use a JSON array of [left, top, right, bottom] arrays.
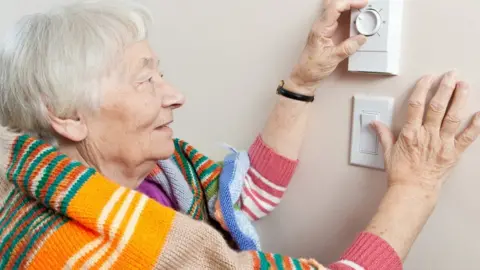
[[261, 80, 311, 160]]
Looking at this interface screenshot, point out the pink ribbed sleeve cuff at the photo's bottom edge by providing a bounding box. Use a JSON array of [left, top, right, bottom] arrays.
[[330, 232, 403, 270]]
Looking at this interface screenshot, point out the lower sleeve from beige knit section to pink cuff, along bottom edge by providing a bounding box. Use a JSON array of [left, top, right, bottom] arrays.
[[158, 211, 402, 270]]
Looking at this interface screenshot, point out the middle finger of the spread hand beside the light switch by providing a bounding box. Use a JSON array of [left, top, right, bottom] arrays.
[[424, 71, 457, 130]]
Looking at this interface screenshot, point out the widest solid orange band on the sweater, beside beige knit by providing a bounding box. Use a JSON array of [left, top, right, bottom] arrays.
[[112, 199, 176, 269]]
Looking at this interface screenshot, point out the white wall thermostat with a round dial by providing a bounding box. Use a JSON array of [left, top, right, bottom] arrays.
[[348, 0, 404, 75]]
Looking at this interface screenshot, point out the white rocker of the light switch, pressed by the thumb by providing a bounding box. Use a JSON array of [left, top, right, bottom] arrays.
[[360, 112, 378, 155]]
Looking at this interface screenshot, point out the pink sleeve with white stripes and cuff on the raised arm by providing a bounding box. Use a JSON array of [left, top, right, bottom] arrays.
[[241, 136, 298, 220]]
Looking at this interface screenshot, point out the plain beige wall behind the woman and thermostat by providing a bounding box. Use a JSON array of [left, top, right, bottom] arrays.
[[0, 0, 480, 270]]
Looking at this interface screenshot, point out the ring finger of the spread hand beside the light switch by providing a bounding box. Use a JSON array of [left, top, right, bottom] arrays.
[[440, 82, 469, 138]]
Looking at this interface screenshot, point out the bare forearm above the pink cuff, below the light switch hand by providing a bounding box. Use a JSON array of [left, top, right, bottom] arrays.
[[366, 186, 437, 261]]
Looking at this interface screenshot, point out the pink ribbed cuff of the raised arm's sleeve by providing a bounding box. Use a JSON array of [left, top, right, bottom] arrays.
[[248, 135, 298, 187]]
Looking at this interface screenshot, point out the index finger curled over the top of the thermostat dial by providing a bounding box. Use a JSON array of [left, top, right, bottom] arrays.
[[313, 0, 367, 35]]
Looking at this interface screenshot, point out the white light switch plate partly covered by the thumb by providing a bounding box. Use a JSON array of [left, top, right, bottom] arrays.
[[350, 95, 394, 169]]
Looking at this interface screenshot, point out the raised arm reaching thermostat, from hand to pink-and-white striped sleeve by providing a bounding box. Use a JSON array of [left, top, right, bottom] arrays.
[[242, 0, 367, 220]]
